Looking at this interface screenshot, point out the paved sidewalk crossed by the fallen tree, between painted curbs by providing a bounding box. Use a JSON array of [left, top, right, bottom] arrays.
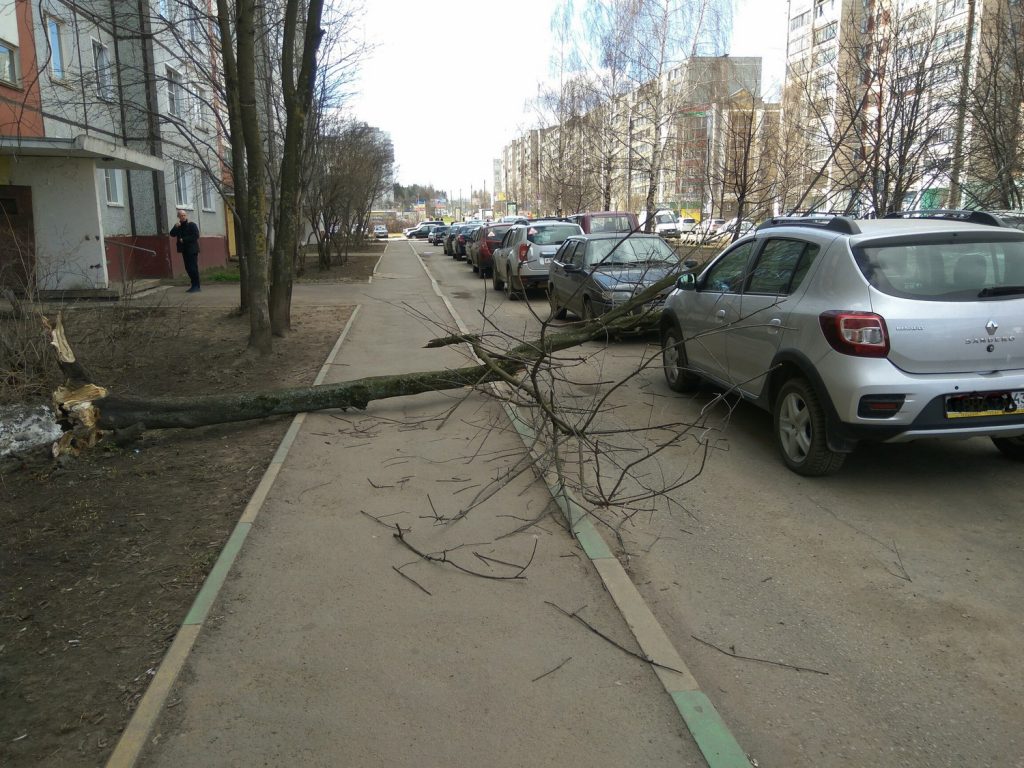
[[110, 243, 706, 767]]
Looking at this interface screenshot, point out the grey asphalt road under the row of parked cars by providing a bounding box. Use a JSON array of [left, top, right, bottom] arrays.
[[407, 241, 1024, 768]]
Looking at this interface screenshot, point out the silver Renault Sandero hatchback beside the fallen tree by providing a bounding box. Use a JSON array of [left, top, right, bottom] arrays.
[[660, 213, 1024, 476]]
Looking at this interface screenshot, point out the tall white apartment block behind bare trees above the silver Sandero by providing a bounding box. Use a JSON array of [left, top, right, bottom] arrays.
[[783, 0, 1024, 215]]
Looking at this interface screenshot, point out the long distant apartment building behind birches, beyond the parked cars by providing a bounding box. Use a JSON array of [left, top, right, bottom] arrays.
[[501, 56, 777, 217]]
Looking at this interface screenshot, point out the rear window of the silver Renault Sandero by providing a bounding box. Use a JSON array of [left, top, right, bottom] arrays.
[[855, 238, 1024, 301]]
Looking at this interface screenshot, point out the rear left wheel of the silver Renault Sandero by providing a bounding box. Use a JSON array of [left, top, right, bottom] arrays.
[[772, 378, 846, 477]]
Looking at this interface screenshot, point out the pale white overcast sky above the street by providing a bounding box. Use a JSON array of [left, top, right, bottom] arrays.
[[349, 0, 786, 197]]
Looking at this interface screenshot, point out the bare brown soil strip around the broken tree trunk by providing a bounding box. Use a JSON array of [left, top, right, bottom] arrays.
[[0, 253, 379, 768]]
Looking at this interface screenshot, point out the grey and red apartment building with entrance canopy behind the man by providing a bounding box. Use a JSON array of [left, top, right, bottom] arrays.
[[0, 0, 227, 293]]
